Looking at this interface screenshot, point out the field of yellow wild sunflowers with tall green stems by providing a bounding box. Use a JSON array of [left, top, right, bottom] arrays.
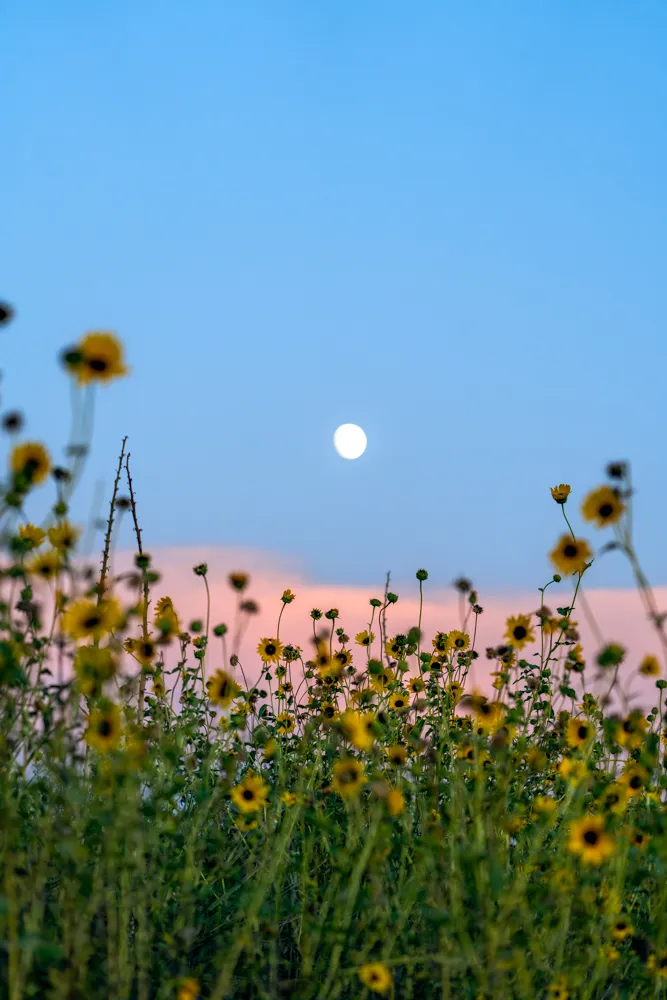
[[0, 306, 667, 1000]]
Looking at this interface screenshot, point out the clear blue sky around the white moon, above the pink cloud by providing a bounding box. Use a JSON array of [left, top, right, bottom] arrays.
[[0, 0, 667, 590]]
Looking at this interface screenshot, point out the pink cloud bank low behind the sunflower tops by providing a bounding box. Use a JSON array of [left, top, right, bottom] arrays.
[[102, 546, 667, 709]]
